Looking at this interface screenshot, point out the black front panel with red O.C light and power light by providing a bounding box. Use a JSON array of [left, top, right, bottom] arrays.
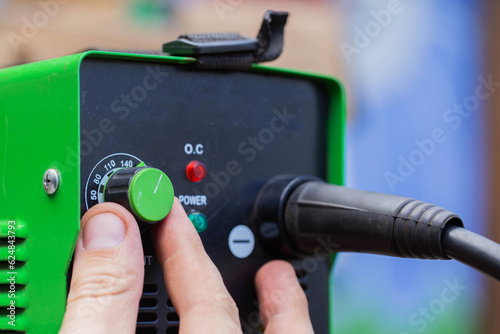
[[80, 58, 330, 334]]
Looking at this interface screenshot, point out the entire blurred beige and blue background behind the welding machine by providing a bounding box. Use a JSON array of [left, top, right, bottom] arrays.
[[0, 0, 500, 334]]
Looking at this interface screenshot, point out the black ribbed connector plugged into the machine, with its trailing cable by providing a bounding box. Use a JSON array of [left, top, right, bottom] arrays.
[[255, 176, 500, 280]]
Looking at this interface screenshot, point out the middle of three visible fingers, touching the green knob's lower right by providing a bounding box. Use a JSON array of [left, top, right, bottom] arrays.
[[152, 198, 241, 333]]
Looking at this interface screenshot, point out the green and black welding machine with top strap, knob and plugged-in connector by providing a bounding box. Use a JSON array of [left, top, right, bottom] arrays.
[[0, 12, 498, 334]]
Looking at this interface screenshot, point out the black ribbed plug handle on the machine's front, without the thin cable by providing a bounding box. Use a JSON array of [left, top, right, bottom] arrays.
[[284, 182, 463, 259]]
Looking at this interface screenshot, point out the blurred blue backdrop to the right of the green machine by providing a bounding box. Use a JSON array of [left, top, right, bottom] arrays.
[[333, 0, 490, 334]]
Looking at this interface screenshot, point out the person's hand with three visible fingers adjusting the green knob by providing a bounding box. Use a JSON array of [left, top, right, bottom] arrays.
[[60, 199, 313, 334]]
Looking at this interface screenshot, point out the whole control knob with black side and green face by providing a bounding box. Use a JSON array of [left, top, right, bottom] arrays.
[[104, 167, 174, 223]]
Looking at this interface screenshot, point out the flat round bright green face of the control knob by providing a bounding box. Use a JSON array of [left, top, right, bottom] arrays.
[[128, 168, 174, 222]]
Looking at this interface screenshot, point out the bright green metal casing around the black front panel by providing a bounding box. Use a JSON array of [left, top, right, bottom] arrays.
[[0, 51, 345, 333]]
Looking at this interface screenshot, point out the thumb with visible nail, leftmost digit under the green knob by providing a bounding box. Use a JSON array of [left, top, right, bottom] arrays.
[[59, 203, 144, 334]]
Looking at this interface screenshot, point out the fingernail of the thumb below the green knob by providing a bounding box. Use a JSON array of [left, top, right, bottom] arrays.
[[83, 213, 125, 250]]
